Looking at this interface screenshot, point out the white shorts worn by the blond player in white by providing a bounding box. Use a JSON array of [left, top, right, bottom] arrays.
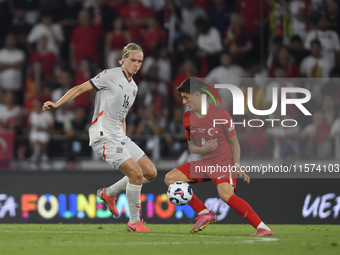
[[92, 139, 145, 169]]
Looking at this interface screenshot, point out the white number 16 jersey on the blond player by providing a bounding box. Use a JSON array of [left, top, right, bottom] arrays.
[[89, 67, 138, 146]]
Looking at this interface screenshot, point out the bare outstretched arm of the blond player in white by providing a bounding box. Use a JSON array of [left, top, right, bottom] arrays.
[[42, 81, 93, 111]]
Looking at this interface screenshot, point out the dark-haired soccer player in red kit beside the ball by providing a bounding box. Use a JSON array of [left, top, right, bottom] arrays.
[[164, 78, 273, 236]]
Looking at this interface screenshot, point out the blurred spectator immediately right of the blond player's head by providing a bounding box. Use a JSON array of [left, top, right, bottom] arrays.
[[141, 45, 172, 82]]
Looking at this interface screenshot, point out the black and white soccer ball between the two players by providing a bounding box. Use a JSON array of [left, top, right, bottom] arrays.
[[167, 181, 192, 205]]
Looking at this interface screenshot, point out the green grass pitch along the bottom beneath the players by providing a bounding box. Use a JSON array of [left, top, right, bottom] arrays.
[[0, 224, 340, 255]]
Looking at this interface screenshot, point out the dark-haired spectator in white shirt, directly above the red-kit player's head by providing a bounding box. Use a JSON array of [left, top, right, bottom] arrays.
[[195, 17, 223, 71]]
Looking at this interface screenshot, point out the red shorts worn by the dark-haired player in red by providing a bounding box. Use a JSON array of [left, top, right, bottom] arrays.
[[176, 160, 237, 189]]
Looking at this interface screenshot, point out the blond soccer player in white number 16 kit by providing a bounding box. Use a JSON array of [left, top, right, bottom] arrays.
[[43, 43, 157, 232]]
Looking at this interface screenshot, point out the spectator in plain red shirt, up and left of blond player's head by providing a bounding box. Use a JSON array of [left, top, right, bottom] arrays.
[[70, 11, 103, 70]]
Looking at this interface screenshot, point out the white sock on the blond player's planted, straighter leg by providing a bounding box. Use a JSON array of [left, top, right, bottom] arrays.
[[126, 182, 142, 224]]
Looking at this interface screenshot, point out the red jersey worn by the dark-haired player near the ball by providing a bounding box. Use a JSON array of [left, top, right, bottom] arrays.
[[183, 104, 236, 162]]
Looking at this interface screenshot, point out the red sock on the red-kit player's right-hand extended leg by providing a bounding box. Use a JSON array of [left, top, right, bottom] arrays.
[[227, 194, 262, 228]]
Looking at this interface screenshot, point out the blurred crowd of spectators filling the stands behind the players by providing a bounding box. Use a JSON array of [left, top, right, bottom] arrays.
[[0, 0, 340, 168]]
